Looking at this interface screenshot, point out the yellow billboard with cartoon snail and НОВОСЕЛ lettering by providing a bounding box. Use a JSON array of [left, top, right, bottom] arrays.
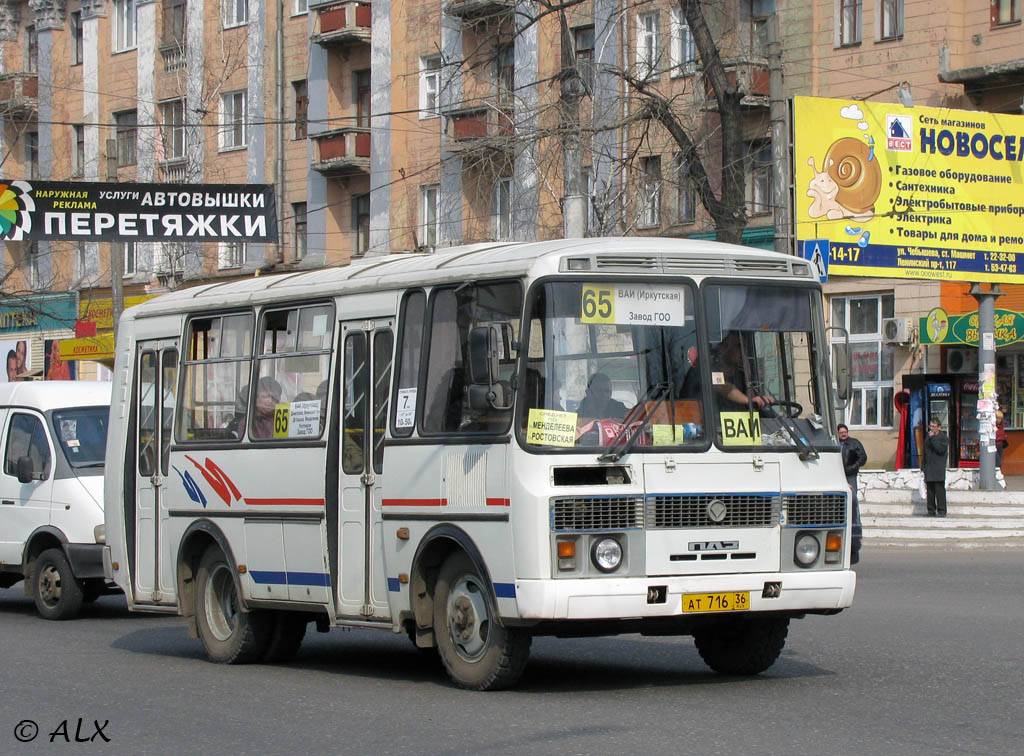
[[793, 97, 1024, 283]]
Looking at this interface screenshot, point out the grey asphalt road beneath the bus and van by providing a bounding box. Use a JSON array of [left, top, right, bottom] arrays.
[[0, 547, 1024, 756]]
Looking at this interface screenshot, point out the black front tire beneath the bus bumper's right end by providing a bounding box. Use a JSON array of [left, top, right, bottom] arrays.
[[693, 617, 790, 675]]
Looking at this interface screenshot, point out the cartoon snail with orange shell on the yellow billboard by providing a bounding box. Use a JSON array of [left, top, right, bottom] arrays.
[[807, 136, 882, 222]]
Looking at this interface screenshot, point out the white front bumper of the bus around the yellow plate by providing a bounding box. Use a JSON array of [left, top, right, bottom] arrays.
[[515, 570, 857, 620]]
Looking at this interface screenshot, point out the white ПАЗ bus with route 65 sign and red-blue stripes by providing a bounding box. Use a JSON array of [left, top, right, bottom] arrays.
[[104, 238, 855, 689]]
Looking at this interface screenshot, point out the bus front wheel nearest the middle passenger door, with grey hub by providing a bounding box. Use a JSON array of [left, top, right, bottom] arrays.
[[433, 552, 532, 690]]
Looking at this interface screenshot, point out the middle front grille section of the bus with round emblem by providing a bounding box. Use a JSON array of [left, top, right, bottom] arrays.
[[647, 494, 781, 530]]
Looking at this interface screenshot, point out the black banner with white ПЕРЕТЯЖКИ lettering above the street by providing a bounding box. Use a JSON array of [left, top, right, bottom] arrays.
[[0, 180, 278, 244]]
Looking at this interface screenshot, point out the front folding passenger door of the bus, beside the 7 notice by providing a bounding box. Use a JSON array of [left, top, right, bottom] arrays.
[[335, 320, 394, 621]]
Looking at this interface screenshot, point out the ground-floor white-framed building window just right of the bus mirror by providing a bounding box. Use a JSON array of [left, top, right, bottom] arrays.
[[829, 294, 894, 428]]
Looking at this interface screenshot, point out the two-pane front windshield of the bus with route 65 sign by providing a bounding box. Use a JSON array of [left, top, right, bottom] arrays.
[[518, 280, 835, 454]]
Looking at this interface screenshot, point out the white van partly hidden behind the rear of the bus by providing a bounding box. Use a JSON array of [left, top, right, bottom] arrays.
[[0, 381, 111, 620]]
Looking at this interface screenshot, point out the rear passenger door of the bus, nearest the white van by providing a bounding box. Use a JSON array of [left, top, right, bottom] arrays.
[[132, 340, 178, 603]]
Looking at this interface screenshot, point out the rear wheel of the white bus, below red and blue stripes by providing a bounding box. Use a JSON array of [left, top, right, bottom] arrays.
[[196, 547, 273, 664]]
